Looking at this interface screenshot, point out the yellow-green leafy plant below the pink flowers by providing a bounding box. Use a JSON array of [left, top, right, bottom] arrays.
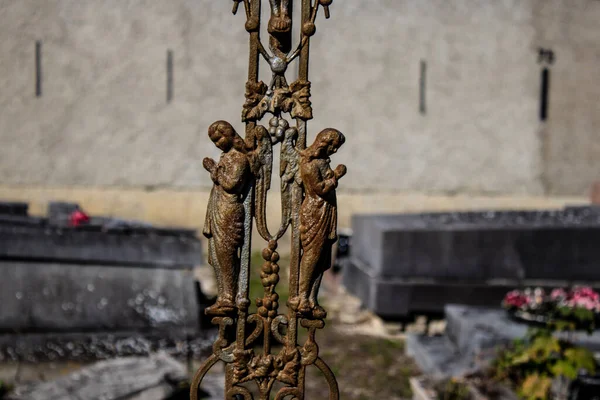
[[493, 327, 597, 400]]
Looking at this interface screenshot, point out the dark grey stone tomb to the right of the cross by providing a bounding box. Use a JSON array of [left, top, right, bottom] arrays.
[[342, 206, 600, 318]]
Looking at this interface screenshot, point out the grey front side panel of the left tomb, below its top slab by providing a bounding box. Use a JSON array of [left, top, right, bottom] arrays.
[[0, 262, 198, 333]]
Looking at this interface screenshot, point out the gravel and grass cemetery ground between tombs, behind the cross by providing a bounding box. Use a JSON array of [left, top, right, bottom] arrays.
[[5, 248, 584, 400]]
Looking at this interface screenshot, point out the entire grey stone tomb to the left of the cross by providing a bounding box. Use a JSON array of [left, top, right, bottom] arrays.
[[0, 203, 207, 361]]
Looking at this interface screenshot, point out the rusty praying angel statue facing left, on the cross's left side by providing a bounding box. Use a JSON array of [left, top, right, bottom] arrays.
[[203, 121, 251, 315]]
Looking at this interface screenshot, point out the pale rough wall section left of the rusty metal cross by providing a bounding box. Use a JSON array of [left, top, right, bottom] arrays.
[[0, 0, 247, 187]]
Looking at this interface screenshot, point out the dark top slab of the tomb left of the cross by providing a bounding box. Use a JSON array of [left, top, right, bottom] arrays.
[[0, 225, 202, 268]]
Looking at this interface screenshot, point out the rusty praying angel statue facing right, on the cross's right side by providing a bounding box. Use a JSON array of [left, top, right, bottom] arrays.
[[290, 129, 346, 319]]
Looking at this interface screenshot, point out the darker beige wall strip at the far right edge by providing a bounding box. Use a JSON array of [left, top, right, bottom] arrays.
[[533, 0, 600, 194]]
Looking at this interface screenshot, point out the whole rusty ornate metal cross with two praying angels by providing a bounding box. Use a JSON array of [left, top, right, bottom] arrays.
[[191, 0, 346, 400]]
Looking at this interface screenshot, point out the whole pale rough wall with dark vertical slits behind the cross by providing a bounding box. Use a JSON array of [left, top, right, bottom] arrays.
[[0, 0, 600, 225]]
